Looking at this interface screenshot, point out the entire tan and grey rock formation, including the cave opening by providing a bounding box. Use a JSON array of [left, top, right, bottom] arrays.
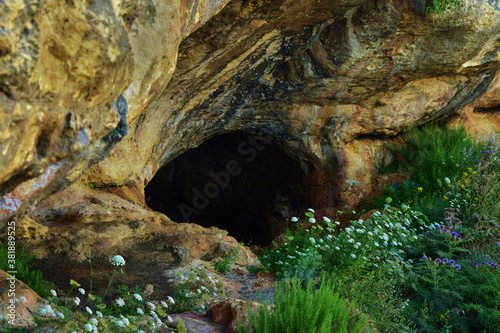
[[0, 0, 500, 296]]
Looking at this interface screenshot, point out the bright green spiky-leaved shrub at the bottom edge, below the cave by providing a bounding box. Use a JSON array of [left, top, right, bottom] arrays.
[[238, 278, 368, 333]]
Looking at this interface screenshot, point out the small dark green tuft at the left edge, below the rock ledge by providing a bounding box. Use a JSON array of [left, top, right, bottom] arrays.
[[0, 244, 49, 297]]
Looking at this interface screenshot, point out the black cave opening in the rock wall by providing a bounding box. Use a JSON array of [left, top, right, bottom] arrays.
[[145, 133, 304, 246]]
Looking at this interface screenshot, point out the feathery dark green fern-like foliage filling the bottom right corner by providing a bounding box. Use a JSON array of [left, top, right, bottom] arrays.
[[406, 257, 500, 332]]
